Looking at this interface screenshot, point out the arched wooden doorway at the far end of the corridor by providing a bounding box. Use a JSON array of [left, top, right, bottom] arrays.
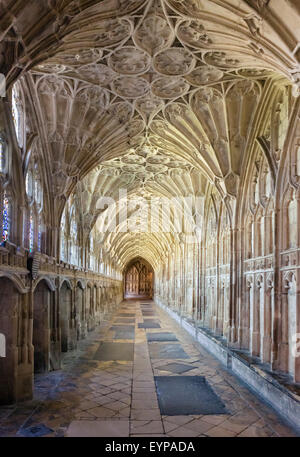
[[124, 258, 154, 298]]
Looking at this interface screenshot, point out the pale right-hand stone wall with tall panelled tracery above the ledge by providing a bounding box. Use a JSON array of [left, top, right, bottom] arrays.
[[155, 96, 300, 383]]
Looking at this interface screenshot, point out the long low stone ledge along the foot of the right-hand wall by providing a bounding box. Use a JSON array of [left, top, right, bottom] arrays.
[[155, 298, 300, 433]]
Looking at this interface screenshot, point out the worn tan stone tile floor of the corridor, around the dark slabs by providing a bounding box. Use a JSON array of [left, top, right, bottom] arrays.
[[0, 300, 296, 437]]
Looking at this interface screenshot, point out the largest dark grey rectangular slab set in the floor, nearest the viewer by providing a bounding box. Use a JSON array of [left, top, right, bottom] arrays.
[[155, 376, 228, 416]]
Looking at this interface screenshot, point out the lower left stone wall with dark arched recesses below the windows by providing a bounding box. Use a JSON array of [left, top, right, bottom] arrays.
[[0, 249, 123, 404]]
